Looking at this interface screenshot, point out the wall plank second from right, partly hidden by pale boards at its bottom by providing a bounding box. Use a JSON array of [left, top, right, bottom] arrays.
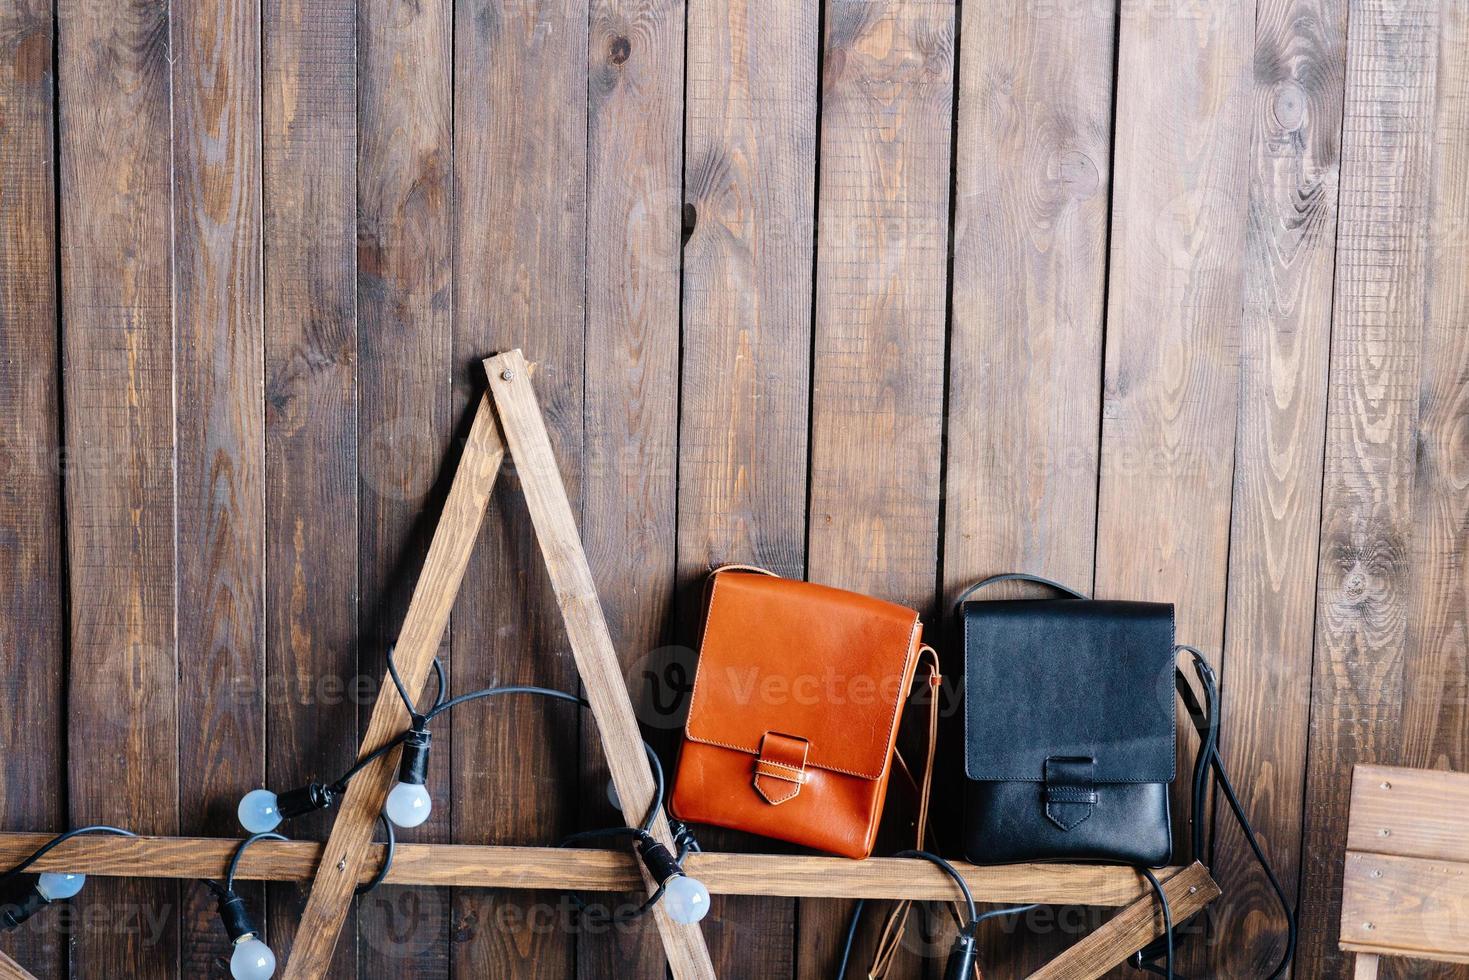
[[1296, 0, 1438, 977]]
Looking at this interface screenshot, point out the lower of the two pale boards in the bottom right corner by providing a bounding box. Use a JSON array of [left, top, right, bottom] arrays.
[[1341, 851, 1469, 962]]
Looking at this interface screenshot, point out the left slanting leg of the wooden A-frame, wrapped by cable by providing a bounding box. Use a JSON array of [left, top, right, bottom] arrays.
[[282, 397, 505, 980]]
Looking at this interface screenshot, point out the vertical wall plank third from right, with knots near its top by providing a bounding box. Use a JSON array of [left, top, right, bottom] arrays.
[[1202, 0, 1347, 976]]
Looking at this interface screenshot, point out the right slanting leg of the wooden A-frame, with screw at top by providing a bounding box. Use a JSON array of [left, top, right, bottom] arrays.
[[484, 350, 715, 980]]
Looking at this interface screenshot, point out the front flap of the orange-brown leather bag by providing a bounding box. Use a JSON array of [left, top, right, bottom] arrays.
[[686, 570, 920, 779]]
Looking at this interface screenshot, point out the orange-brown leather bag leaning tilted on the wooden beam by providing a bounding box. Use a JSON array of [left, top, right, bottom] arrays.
[[671, 566, 937, 858]]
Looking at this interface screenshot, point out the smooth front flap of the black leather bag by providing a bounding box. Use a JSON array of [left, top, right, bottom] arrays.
[[962, 599, 1177, 783]]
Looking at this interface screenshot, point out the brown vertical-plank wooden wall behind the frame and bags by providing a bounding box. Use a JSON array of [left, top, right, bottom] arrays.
[[0, 0, 1469, 980]]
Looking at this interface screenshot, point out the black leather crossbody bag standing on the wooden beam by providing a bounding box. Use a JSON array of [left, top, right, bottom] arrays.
[[959, 574, 1177, 867]]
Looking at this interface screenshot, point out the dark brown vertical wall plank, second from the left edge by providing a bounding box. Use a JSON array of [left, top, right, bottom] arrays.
[[57, 0, 179, 977]]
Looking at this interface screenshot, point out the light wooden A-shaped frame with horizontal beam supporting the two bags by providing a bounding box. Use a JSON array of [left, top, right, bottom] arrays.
[[0, 351, 1219, 980]]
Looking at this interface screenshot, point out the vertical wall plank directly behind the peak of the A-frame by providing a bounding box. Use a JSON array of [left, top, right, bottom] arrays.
[[452, 0, 588, 980]]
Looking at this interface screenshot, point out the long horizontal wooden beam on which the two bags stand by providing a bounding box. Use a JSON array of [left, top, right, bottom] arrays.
[[0, 833, 1178, 907]]
